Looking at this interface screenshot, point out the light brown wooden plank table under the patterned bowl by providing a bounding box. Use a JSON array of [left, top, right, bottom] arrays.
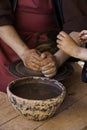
[[0, 64, 87, 130]]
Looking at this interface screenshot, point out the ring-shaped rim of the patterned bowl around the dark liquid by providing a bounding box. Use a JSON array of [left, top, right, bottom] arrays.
[[7, 76, 66, 102]]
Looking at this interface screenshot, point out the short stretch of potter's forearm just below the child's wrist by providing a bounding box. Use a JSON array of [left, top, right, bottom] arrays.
[[54, 50, 70, 67]]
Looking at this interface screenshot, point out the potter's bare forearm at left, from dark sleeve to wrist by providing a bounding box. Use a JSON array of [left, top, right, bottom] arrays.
[[0, 25, 28, 58]]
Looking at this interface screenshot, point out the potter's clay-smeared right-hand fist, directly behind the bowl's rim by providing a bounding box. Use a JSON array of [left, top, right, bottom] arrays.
[[41, 52, 57, 77]]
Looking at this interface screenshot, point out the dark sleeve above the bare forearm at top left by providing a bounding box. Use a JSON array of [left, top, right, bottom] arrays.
[[0, 0, 14, 26]]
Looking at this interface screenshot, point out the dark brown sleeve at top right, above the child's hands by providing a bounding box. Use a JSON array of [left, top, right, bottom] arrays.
[[62, 0, 87, 33]]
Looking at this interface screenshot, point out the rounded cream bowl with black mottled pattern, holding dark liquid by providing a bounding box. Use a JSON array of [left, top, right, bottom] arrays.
[[7, 77, 66, 121]]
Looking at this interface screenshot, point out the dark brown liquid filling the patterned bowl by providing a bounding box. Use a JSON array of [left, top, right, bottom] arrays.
[[11, 83, 61, 100]]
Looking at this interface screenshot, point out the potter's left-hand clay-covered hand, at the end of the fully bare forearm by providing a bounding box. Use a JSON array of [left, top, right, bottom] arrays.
[[22, 49, 41, 71]]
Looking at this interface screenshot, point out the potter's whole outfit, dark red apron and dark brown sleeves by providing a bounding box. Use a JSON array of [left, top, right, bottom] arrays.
[[0, 0, 87, 91]]
